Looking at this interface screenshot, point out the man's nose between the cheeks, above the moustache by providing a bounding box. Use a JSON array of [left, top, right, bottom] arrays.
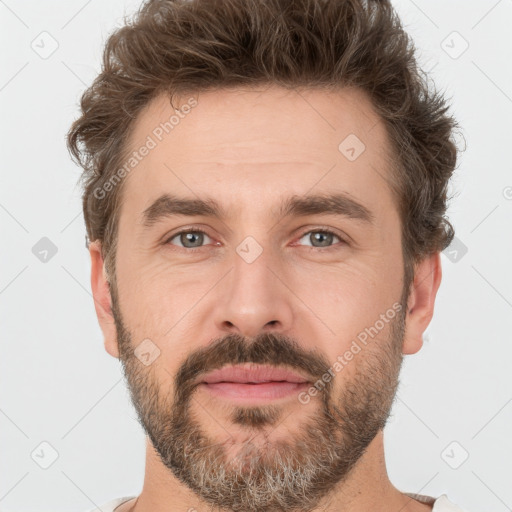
[[215, 241, 294, 337]]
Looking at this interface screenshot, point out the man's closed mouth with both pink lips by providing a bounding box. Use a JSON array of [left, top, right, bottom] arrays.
[[200, 365, 310, 403]]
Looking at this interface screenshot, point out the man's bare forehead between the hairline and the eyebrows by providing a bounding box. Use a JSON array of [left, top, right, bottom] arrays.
[[121, 87, 394, 223]]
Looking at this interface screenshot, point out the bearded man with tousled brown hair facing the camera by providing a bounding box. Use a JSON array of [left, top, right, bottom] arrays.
[[68, 0, 468, 512]]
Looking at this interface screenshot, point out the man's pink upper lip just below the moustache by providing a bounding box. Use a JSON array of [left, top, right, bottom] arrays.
[[200, 365, 309, 384]]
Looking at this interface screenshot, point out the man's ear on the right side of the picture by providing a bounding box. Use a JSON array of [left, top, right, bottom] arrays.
[[402, 252, 442, 354]]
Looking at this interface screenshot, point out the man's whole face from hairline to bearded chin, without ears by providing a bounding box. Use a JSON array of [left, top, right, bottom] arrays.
[[112, 88, 405, 511]]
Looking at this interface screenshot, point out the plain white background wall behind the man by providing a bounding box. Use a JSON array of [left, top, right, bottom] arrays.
[[0, 0, 512, 512]]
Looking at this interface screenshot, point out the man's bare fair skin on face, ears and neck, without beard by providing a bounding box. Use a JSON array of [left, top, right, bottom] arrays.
[[90, 87, 441, 512]]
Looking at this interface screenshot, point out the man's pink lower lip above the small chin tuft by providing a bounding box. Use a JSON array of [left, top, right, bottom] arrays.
[[201, 382, 309, 401]]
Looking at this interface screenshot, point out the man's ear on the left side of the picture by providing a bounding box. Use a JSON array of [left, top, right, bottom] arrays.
[[89, 240, 119, 358]]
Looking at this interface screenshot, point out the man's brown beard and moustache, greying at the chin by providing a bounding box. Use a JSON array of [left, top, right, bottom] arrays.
[[112, 293, 406, 512]]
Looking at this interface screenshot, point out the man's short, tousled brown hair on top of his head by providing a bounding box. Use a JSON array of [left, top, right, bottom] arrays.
[[67, 0, 457, 294]]
